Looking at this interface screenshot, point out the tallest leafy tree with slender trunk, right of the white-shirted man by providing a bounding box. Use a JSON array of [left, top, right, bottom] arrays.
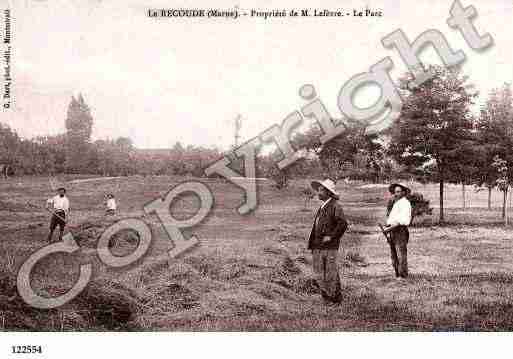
[[389, 66, 477, 223]]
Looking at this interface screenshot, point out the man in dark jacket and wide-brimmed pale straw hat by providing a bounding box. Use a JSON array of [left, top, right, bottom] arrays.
[[308, 179, 348, 303]]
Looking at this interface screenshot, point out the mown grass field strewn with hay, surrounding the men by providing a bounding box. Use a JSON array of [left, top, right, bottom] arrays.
[[0, 177, 513, 331]]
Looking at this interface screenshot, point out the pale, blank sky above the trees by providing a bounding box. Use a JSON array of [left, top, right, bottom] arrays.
[[0, 0, 513, 148]]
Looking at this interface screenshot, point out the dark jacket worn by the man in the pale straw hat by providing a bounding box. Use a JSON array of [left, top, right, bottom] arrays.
[[308, 198, 348, 249]]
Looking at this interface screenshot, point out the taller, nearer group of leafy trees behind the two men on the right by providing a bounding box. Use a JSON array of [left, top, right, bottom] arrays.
[[268, 65, 513, 223]]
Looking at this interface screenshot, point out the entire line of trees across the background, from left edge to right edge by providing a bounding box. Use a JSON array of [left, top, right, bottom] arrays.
[[0, 66, 513, 222]]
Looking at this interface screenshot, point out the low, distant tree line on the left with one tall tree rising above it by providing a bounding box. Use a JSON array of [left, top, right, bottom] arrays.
[[0, 94, 221, 176]]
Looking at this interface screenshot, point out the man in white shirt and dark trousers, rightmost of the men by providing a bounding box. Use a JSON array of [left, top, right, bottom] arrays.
[[385, 183, 412, 279]]
